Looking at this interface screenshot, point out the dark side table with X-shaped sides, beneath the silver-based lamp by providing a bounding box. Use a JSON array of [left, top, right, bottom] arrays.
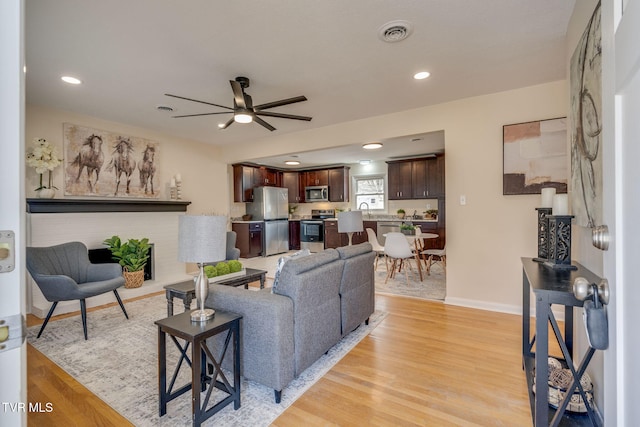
[[155, 310, 242, 426]]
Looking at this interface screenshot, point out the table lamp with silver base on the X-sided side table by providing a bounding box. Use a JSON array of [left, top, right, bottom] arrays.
[[178, 215, 227, 322]]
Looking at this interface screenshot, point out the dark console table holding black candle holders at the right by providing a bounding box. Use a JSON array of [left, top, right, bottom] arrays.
[[522, 258, 603, 427]]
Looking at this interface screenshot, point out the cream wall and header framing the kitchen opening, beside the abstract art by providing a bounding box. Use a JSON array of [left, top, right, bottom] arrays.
[[222, 81, 568, 313]]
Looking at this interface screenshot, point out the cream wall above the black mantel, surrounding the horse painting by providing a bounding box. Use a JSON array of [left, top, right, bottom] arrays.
[[25, 105, 229, 215]]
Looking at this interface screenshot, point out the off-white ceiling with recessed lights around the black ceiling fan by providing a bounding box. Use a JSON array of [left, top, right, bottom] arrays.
[[25, 0, 575, 166]]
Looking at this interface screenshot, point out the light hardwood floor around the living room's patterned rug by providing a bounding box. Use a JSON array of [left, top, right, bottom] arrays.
[[27, 295, 531, 427]]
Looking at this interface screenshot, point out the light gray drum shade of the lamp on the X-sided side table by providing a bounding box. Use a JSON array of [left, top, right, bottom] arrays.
[[178, 215, 227, 263]]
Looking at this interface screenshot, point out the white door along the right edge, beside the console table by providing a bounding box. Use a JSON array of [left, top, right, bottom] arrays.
[[604, 1, 640, 426]]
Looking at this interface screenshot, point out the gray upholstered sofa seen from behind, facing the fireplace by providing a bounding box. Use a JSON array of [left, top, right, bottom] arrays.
[[205, 243, 375, 403]]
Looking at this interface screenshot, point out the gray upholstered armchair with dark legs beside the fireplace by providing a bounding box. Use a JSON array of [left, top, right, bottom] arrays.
[[27, 242, 129, 340]]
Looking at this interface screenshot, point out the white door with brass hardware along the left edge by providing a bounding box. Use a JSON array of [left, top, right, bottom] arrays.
[[0, 0, 28, 427]]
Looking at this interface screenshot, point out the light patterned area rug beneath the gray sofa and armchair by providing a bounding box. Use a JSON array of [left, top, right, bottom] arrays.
[[28, 295, 386, 427]]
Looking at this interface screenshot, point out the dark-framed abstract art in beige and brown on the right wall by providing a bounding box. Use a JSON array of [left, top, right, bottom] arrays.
[[502, 117, 569, 195]]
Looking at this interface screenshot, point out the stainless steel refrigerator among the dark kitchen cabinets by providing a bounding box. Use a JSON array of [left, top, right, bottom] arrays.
[[247, 187, 289, 256]]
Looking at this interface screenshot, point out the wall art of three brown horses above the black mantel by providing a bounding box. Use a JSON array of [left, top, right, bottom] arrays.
[[63, 123, 160, 198]]
